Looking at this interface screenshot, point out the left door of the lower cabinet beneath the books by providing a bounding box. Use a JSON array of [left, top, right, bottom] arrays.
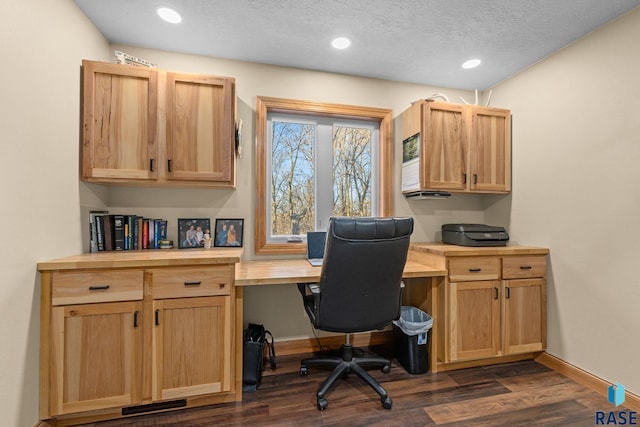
[[50, 301, 142, 415]]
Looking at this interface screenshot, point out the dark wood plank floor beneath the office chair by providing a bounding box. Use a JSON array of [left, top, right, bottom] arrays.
[[81, 349, 621, 427]]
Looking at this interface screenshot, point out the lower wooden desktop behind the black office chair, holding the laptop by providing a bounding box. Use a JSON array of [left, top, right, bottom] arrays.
[[236, 259, 447, 286]]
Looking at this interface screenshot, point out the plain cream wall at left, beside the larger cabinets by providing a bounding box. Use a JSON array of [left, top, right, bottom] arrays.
[[0, 0, 109, 427]]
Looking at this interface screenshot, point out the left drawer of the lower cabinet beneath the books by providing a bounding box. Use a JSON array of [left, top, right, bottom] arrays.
[[51, 270, 144, 305]]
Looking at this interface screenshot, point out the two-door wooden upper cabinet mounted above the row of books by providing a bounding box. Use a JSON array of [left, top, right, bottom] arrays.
[[82, 60, 235, 187]]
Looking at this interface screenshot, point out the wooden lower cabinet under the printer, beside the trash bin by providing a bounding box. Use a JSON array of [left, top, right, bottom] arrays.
[[442, 255, 546, 363]]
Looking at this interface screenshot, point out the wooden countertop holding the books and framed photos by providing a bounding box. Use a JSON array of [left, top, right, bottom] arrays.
[[38, 248, 242, 271]]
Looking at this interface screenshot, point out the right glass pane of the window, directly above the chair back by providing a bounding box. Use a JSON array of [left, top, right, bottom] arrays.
[[333, 126, 372, 216]]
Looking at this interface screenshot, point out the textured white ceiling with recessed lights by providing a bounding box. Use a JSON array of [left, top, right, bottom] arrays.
[[75, 0, 640, 90]]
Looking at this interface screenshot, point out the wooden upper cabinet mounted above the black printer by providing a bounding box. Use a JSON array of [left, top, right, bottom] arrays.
[[401, 100, 511, 194]]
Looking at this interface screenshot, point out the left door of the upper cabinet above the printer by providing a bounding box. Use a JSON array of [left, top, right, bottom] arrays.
[[420, 102, 468, 190]]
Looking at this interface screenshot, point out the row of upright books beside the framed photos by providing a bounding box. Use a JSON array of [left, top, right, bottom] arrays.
[[89, 211, 167, 252]]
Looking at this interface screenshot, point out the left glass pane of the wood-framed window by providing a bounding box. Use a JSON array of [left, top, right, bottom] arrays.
[[271, 120, 316, 236]]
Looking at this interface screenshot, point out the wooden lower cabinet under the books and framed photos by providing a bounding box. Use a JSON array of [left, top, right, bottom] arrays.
[[40, 255, 242, 425]]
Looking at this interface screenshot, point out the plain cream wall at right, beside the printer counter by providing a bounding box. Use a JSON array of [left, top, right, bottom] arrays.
[[486, 8, 640, 394]]
